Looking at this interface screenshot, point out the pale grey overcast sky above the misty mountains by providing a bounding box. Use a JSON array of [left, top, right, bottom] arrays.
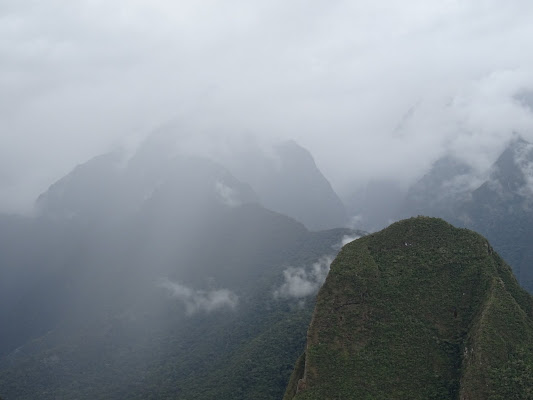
[[0, 0, 533, 211]]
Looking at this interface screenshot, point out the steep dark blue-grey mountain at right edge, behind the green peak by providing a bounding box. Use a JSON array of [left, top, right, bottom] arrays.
[[456, 137, 533, 292]]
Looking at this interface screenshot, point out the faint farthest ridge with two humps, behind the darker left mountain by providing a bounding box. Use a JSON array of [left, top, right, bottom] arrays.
[[37, 135, 347, 230]]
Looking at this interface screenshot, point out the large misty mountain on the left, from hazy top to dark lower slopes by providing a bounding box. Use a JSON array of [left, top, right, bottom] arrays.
[[0, 141, 362, 400]]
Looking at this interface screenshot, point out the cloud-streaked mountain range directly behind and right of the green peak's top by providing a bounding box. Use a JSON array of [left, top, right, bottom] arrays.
[[350, 135, 533, 292]]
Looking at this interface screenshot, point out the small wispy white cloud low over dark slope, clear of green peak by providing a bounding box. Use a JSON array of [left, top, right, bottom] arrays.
[[159, 279, 239, 315]]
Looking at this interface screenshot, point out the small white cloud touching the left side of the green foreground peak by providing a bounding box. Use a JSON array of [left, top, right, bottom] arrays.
[[274, 256, 333, 299]]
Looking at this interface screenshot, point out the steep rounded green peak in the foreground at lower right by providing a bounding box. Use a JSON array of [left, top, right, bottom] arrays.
[[285, 217, 533, 400]]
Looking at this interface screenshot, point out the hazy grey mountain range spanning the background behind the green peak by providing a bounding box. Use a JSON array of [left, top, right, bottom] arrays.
[[0, 134, 533, 400]]
